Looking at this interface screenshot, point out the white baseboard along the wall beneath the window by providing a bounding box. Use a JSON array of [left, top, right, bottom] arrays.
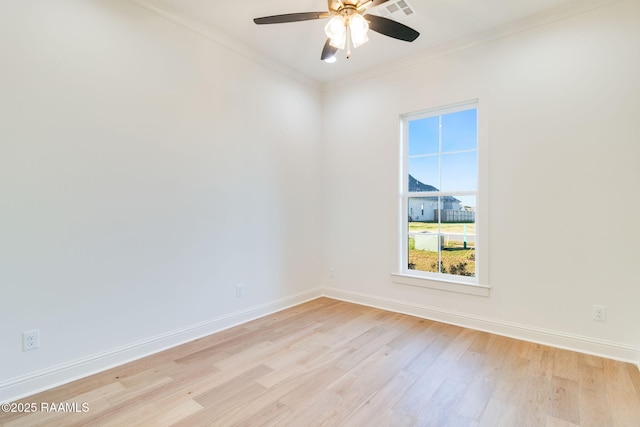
[[322, 288, 640, 369]]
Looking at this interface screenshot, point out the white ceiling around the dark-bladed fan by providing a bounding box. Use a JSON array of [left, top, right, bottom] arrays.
[[133, 0, 593, 83]]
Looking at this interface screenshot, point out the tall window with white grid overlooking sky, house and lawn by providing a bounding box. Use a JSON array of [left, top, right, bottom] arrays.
[[400, 102, 478, 284]]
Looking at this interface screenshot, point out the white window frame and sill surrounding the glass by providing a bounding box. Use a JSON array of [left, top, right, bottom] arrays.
[[391, 100, 490, 296]]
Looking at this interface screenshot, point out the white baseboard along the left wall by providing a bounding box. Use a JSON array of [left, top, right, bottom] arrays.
[[0, 288, 322, 402]]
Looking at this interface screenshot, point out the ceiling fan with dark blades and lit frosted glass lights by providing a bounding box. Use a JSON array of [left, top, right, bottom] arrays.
[[253, 0, 420, 62]]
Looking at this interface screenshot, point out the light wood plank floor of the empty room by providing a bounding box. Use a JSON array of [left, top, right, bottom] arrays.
[[0, 298, 640, 427]]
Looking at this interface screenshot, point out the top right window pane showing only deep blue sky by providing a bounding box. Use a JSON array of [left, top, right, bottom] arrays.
[[442, 109, 478, 152]]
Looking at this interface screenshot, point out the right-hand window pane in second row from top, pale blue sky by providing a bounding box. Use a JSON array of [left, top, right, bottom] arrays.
[[440, 151, 478, 191]]
